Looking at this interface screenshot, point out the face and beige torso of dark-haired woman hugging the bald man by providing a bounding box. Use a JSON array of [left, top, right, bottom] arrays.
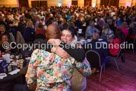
[[61, 27, 91, 91]]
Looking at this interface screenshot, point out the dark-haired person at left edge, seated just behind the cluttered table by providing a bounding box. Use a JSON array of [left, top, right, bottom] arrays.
[[0, 34, 13, 53]]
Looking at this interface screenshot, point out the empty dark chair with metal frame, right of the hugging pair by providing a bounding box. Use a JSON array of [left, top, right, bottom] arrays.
[[86, 50, 106, 82]]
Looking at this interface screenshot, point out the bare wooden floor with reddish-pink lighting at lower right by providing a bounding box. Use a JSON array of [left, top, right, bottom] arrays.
[[86, 51, 136, 91]]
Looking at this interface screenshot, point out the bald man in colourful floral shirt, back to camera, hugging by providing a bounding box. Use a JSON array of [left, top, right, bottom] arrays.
[[26, 24, 91, 91]]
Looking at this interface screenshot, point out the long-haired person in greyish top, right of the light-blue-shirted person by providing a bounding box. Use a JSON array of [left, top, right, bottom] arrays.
[[101, 23, 114, 40]]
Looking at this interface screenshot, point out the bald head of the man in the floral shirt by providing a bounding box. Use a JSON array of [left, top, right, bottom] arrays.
[[45, 24, 61, 40]]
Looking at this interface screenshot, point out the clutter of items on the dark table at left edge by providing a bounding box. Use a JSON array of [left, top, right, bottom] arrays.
[[0, 54, 30, 73]]
